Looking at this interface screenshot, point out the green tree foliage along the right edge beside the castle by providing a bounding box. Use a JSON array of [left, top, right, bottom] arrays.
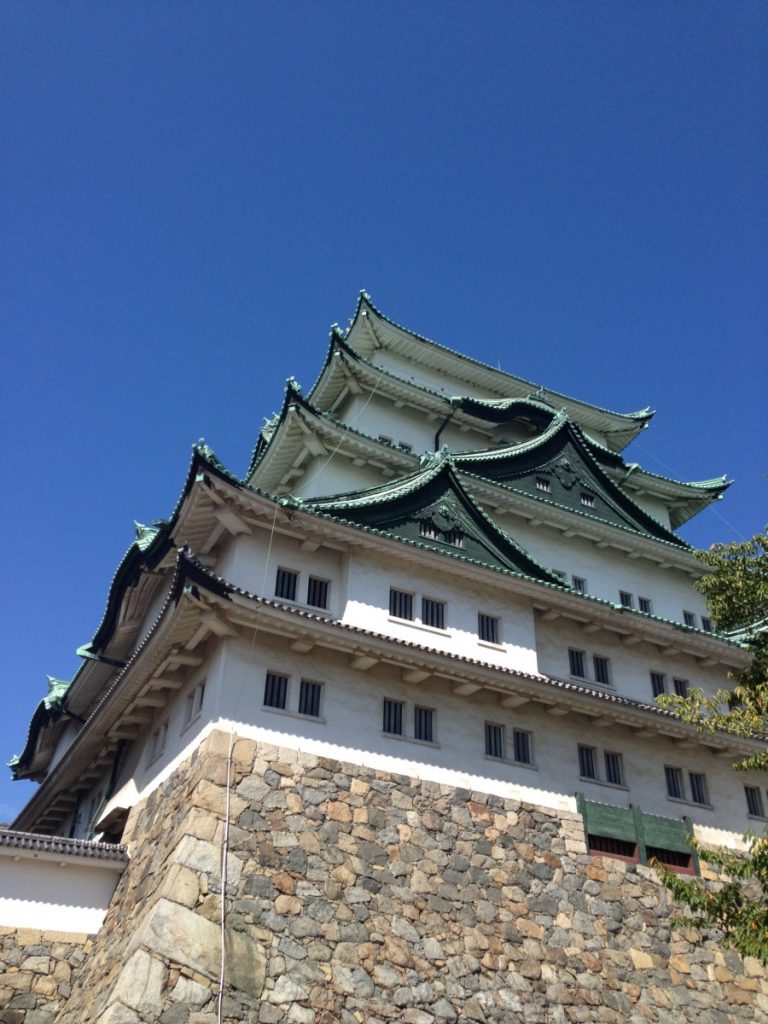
[[652, 531, 768, 964]]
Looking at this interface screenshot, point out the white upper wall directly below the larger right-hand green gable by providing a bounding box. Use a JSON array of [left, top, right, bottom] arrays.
[[496, 515, 708, 626]]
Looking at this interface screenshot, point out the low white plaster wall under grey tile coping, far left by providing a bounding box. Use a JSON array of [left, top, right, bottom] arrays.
[[0, 851, 123, 934]]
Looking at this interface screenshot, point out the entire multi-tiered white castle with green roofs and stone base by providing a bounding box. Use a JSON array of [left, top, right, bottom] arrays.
[[0, 293, 768, 1024]]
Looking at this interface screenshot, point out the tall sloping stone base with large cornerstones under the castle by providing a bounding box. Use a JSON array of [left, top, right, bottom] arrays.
[[48, 733, 768, 1024]]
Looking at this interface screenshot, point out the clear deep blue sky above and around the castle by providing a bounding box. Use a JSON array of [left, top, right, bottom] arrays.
[[0, 0, 768, 820]]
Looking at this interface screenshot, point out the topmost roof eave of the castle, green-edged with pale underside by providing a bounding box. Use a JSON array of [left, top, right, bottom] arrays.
[[346, 291, 654, 451]]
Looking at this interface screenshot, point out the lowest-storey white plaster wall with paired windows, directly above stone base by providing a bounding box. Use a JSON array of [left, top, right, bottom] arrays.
[[207, 641, 768, 842]]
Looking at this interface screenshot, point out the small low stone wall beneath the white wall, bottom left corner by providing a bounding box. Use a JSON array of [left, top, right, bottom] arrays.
[[0, 927, 92, 1024]]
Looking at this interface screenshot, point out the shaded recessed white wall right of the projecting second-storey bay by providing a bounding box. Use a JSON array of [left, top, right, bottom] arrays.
[[537, 617, 728, 703]]
